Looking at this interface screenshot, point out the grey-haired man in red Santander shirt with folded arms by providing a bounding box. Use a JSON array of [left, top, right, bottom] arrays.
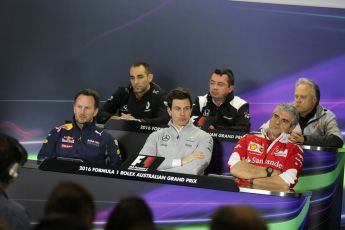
[[228, 104, 303, 191]]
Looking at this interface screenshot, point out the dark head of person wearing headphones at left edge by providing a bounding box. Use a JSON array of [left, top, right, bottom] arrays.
[[0, 134, 28, 183]]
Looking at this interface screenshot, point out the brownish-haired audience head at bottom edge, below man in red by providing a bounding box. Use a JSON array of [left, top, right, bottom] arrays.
[[210, 206, 267, 230]]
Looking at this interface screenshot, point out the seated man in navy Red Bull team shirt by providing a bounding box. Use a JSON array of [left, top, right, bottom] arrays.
[[37, 89, 121, 166]]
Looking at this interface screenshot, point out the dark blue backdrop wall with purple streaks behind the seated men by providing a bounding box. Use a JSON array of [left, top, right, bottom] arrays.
[[0, 0, 345, 226]]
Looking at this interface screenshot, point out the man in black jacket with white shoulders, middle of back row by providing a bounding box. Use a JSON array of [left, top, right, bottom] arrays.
[[192, 69, 250, 132]]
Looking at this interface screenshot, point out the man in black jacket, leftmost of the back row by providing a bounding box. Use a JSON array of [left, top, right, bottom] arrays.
[[97, 62, 169, 124]]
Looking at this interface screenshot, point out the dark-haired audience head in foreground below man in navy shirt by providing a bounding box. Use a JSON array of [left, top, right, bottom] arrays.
[[45, 181, 95, 226]]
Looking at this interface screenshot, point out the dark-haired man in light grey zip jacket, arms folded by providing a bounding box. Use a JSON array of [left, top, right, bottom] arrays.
[[139, 87, 213, 175]]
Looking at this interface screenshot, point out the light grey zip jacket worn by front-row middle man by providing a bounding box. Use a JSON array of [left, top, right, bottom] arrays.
[[139, 120, 213, 175]]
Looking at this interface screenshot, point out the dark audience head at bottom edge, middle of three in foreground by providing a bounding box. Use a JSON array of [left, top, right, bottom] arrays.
[[105, 197, 154, 230]]
